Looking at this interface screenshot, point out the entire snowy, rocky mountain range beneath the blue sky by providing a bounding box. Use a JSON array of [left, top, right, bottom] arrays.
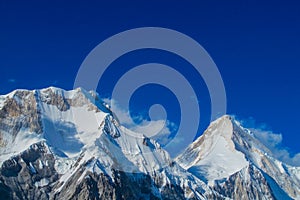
[[0, 87, 299, 199]]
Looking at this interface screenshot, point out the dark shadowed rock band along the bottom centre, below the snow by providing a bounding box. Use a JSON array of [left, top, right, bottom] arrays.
[[50, 161, 195, 200]]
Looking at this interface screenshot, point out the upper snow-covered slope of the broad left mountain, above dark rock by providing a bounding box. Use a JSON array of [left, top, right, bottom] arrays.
[[0, 87, 171, 172]]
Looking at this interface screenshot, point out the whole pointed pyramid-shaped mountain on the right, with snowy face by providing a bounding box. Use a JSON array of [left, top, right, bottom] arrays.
[[176, 116, 300, 199]]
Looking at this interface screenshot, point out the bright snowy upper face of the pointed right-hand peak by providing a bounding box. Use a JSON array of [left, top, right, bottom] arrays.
[[177, 116, 249, 182]]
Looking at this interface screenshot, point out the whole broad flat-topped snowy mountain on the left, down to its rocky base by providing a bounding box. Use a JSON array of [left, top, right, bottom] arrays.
[[0, 87, 221, 199]]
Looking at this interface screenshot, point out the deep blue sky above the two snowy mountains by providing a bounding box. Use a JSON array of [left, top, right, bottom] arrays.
[[0, 0, 300, 153]]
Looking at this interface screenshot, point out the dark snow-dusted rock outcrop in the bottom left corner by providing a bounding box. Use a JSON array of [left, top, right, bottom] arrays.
[[0, 142, 59, 199]]
